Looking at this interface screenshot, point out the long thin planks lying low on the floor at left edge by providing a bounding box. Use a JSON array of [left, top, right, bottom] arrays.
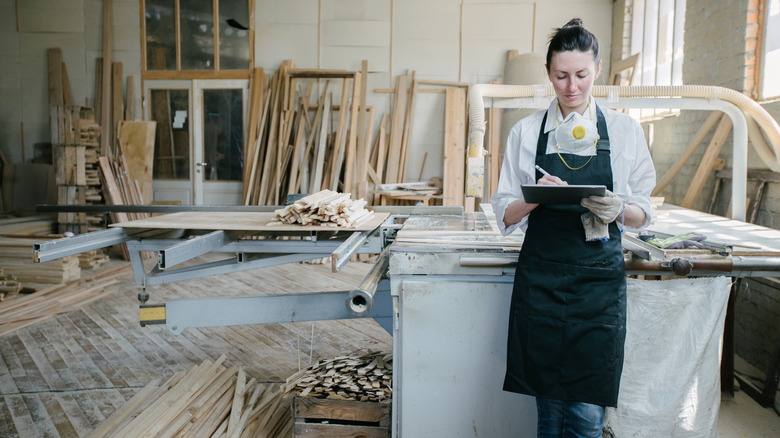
[[0, 264, 130, 337]]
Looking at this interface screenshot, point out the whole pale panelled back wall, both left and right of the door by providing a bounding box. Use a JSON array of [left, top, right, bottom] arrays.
[[0, 0, 612, 185]]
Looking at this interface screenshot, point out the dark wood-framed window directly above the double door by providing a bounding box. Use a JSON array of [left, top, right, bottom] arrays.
[[142, 0, 253, 78]]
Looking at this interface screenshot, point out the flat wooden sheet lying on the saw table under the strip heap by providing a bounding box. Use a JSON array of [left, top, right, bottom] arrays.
[[110, 212, 390, 231]]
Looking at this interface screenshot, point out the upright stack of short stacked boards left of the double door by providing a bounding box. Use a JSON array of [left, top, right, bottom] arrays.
[[50, 105, 105, 234]]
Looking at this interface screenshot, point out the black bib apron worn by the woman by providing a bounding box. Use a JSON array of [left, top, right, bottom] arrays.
[[504, 107, 626, 407]]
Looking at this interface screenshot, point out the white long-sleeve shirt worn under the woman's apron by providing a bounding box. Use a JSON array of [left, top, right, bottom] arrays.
[[490, 98, 655, 236]]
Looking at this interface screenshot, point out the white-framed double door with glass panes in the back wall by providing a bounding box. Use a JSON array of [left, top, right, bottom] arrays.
[[144, 80, 248, 205]]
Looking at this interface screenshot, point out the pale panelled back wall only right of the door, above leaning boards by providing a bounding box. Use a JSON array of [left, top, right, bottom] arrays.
[[255, 0, 612, 180]]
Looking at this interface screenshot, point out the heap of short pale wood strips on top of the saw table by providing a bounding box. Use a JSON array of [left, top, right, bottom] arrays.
[[275, 189, 373, 227]]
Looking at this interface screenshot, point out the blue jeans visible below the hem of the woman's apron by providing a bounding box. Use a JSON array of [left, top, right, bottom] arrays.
[[536, 397, 604, 438]]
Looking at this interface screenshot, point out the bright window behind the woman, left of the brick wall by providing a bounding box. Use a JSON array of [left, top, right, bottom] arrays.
[[626, 0, 685, 120]]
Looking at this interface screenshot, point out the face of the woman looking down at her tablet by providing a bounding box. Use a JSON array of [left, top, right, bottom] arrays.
[[547, 51, 601, 117]]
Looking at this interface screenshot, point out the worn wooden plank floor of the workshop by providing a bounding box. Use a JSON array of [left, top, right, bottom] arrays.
[[0, 255, 780, 438]]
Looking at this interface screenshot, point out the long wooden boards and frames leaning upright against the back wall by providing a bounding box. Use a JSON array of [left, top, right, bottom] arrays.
[[243, 60, 468, 205]]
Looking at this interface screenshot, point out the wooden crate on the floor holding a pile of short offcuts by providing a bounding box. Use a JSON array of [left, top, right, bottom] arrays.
[[293, 396, 391, 438]]
